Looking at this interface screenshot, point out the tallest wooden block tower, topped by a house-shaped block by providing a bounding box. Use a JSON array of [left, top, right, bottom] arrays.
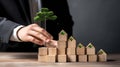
[[57, 30, 68, 62]]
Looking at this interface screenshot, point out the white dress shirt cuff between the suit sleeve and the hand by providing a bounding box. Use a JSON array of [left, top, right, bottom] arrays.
[[10, 25, 24, 42]]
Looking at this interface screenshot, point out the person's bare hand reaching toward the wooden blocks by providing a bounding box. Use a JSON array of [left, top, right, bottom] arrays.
[[18, 24, 53, 45]]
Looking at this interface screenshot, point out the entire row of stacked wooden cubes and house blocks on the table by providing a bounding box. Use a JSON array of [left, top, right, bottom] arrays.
[[38, 30, 107, 63]]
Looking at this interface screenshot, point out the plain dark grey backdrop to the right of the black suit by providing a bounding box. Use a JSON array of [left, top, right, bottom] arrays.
[[68, 0, 120, 53]]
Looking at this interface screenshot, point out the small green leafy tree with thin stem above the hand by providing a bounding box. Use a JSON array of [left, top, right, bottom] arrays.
[[34, 8, 57, 27]]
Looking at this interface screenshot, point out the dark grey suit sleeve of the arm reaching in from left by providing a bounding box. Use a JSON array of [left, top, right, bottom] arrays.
[[0, 17, 19, 43]]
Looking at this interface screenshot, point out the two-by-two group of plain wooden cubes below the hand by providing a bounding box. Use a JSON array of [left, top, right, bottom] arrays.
[[38, 47, 57, 62]]
